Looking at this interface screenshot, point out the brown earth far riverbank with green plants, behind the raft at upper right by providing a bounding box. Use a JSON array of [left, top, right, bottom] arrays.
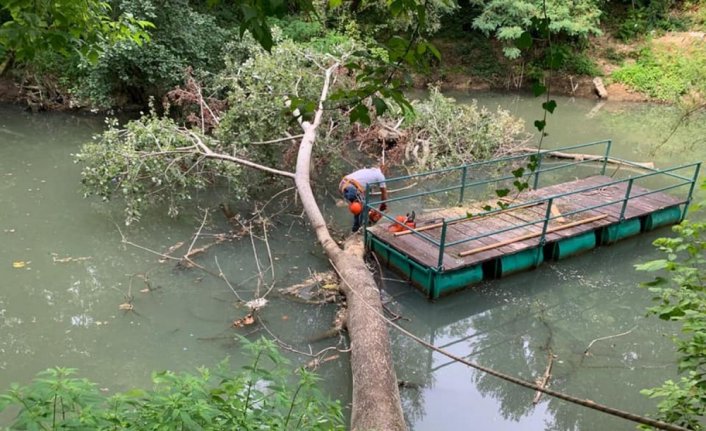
[[415, 31, 706, 103]]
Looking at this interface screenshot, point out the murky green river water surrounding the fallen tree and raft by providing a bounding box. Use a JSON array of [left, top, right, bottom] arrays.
[[0, 94, 706, 431]]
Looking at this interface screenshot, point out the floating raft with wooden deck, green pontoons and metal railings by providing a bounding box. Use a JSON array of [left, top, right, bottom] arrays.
[[364, 141, 701, 299]]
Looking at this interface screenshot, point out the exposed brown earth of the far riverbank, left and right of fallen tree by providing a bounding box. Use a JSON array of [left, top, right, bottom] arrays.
[[0, 31, 706, 111]]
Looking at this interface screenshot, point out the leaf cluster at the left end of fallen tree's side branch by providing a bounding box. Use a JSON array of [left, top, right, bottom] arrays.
[[76, 112, 243, 224]]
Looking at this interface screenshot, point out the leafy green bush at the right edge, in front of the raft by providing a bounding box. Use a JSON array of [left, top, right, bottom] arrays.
[[637, 183, 706, 430]]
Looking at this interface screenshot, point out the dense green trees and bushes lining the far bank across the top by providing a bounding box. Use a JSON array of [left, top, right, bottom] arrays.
[[0, 0, 706, 109]]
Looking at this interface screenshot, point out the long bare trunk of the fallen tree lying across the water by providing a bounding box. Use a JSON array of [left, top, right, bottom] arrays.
[[294, 64, 407, 431]]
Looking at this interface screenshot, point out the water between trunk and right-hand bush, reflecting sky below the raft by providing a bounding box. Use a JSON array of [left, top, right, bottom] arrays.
[[393, 232, 675, 431]]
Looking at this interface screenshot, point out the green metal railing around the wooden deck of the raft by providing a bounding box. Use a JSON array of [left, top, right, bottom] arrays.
[[363, 140, 701, 271]]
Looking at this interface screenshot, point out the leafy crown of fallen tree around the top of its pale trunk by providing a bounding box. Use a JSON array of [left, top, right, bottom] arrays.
[[216, 32, 354, 159]]
